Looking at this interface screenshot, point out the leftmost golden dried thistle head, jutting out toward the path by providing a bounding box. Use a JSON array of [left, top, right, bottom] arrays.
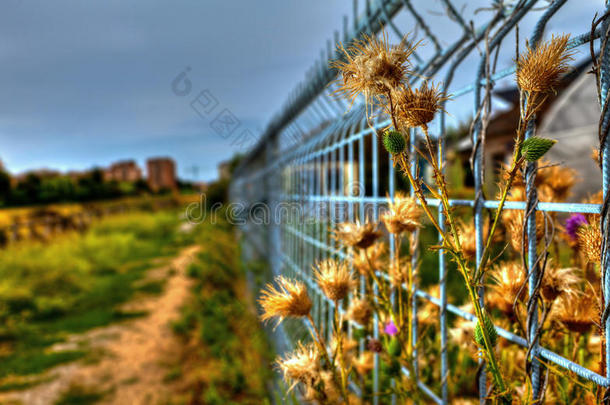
[[259, 276, 312, 324]]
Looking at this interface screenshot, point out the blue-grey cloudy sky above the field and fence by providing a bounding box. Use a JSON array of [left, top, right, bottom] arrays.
[[0, 0, 603, 181]]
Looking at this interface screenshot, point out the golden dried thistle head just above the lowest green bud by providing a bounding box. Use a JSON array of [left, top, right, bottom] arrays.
[[489, 262, 527, 319]]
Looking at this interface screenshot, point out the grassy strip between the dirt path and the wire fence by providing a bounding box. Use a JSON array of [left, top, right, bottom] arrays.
[[168, 219, 272, 405]]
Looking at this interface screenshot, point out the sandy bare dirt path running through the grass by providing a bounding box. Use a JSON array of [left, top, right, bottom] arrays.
[[0, 246, 199, 405]]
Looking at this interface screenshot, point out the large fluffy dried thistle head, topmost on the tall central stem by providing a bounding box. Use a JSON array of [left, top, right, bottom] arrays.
[[330, 32, 418, 104]]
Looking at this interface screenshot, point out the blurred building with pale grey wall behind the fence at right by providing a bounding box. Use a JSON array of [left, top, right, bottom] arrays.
[[456, 59, 601, 202]]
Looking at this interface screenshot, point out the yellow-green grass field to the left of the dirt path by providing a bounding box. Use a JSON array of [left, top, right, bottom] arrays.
[[0, 211, 192, 378]]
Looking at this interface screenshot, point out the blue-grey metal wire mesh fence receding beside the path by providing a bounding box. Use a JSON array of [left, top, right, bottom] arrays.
[[231, 0, 610, 404]]
